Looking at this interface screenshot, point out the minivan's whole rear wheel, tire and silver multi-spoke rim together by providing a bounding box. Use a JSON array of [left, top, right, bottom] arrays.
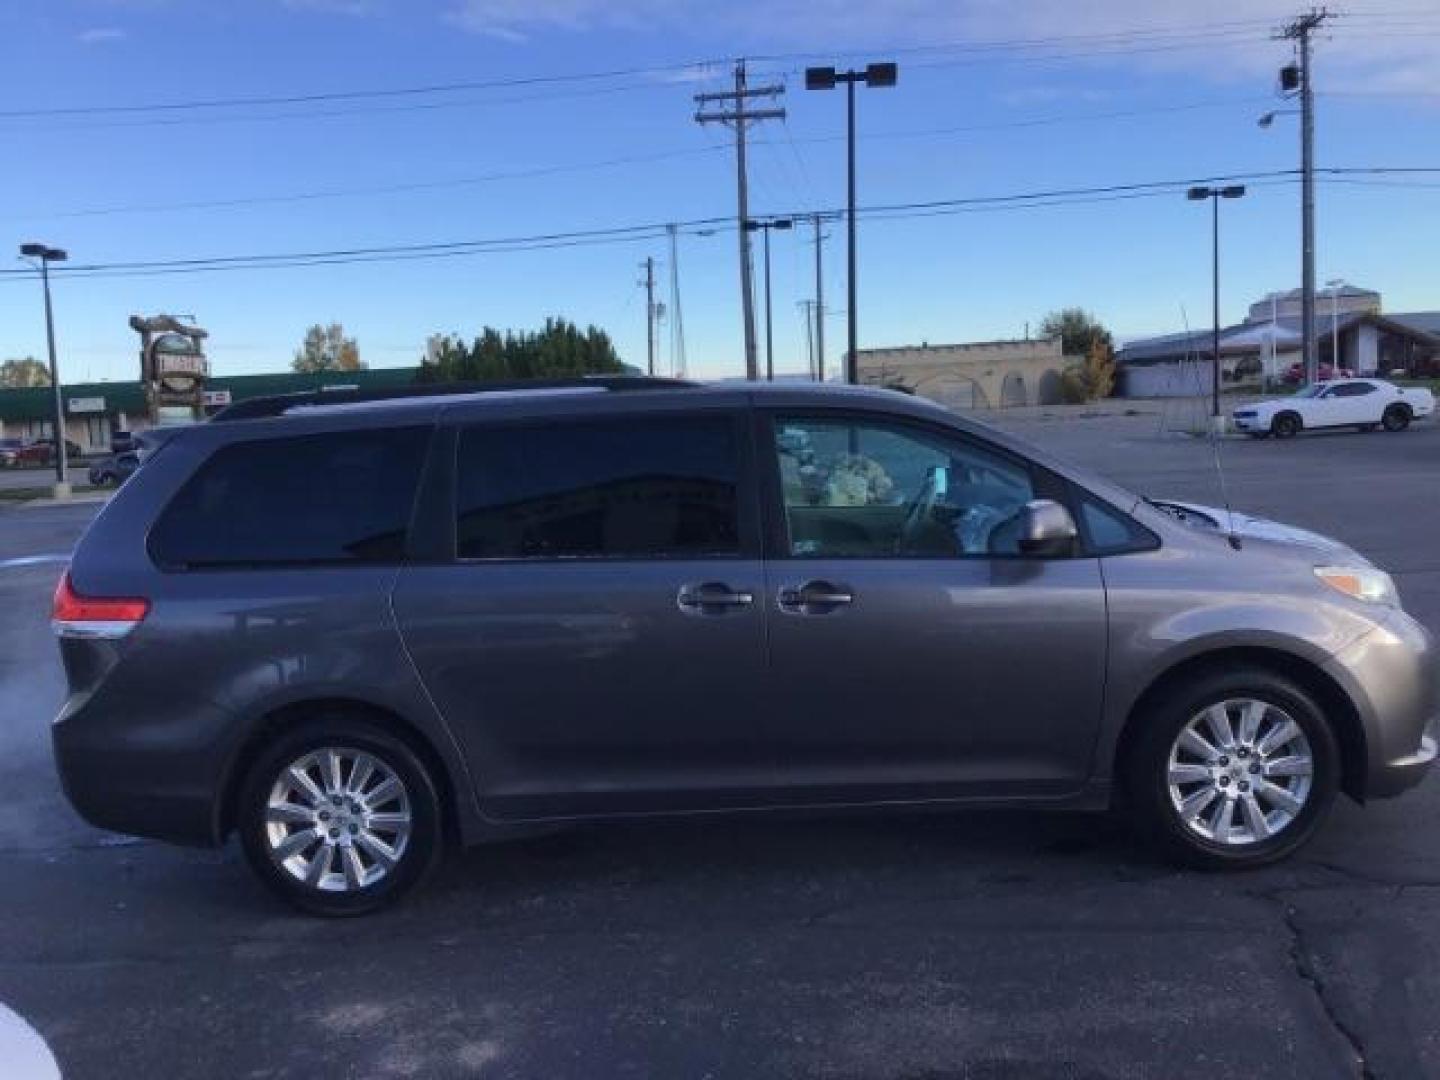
[[236, 717, 442, 916]]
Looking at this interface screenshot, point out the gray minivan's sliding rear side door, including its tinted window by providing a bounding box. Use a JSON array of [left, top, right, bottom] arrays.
[[395, 410, 773, 819]]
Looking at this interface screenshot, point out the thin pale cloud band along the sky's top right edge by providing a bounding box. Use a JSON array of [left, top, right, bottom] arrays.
[[445, 0, 1440, 92]]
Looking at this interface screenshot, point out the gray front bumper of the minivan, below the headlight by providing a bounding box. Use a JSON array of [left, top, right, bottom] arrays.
[[1326, 611, 1440, 799]]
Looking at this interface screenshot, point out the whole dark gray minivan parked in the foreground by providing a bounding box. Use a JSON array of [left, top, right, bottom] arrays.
[[52, 379, 1440, 914]]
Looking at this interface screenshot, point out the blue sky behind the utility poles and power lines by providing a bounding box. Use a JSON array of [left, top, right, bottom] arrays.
[[0, 0, 1440, 380]]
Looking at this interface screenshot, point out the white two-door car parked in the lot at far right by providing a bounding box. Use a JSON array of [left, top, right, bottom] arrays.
[[1231, 379, 1436, 439]]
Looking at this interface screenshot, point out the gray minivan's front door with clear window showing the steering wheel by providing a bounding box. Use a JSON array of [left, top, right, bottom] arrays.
[[757, 410, 1106, 802]]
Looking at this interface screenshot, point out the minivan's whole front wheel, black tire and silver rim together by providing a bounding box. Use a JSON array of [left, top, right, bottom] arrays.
[[1126, 668, 1339, 870]]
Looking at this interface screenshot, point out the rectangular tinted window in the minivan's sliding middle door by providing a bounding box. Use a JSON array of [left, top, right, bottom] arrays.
[[456, 416, 740, 559]]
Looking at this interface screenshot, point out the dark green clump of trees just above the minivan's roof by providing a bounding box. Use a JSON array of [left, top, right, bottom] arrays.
[[416, 318, 625, 383]]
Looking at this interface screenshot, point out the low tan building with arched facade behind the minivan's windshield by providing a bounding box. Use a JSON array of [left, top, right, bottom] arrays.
[[857, 338, 1079, 409]]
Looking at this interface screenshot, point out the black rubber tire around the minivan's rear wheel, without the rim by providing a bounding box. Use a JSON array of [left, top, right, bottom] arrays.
[[235, 714, 444, 917]]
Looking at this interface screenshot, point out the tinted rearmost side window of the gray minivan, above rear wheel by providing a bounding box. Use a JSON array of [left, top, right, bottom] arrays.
[[150, 428, 431, 569]]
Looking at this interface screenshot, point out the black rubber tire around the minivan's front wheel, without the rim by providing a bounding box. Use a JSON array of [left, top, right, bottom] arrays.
[[1123, 668, 1341, 870]]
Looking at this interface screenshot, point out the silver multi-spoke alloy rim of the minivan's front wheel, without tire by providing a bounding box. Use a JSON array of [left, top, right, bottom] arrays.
[[1166, 698, 1315, 847]]
